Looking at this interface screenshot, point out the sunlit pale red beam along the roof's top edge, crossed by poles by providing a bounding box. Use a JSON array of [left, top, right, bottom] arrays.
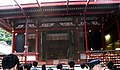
[[0, 0, 120, 10]]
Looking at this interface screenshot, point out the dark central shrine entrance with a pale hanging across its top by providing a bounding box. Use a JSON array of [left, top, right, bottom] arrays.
[[40, 31, 74, 60]]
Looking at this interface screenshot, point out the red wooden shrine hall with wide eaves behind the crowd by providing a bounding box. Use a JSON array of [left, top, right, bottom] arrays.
[[0, 0, 120, 64]]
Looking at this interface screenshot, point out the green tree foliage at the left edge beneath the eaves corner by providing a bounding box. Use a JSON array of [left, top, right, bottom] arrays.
[[0, 28, 12, 45]]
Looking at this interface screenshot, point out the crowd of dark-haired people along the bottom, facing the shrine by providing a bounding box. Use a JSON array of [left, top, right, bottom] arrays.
[[2, 54, 119, 70]]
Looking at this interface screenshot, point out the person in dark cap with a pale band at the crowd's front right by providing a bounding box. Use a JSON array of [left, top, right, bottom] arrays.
[[88, 59, 102, 70]]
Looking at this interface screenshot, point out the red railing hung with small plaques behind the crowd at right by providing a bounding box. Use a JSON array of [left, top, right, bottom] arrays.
[[87, 50, 120, 68]]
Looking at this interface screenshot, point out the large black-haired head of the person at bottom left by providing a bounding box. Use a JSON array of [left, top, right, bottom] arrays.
[[2, 54, 19, 70]]
